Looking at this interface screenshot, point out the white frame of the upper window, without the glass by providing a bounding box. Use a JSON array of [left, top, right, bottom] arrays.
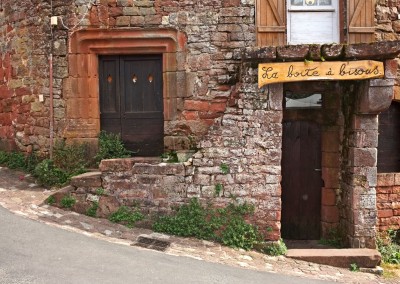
[[286, 0, 340, 44]]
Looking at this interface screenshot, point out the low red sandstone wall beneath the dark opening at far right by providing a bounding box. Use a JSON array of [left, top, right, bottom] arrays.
[[376, 173, 400, 231]]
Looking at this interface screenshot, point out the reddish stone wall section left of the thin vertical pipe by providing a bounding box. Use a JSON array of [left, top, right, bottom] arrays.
[[0, 1, 59, 152]]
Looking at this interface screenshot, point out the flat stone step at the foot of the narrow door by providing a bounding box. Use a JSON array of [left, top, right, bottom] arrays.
[[286, 249, 381, 268]]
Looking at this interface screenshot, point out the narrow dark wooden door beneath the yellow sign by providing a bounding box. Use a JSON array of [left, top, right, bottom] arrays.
[[282, 121, 322, 240]]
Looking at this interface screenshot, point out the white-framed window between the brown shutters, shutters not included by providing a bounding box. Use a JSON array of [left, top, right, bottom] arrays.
[[287, 0, 339, 44]]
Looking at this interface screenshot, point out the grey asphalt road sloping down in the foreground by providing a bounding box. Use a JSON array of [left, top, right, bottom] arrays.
[[0, 207, 329, 284]]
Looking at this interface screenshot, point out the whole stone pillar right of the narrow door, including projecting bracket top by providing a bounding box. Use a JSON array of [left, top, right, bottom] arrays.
[[342, 74, 394, 248]]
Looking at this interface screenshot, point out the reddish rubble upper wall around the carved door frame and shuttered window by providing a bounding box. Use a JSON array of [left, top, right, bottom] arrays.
[[0, 0, 400, 155]]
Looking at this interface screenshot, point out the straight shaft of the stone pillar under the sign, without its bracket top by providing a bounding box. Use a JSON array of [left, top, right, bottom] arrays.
[[343, 114, 378, 248]]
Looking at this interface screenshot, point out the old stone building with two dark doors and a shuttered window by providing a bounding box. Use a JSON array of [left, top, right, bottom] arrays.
[[0, 0, 400, 247]]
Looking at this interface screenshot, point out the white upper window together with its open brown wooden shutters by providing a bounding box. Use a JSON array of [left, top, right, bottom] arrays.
[[256, 0, 376, 46]]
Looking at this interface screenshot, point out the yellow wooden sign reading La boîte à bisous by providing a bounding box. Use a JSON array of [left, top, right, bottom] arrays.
[[258, 60, 385, 88]]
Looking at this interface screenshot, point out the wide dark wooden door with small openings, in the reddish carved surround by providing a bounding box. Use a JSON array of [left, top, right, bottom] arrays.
[[99, 55, 164, 156]]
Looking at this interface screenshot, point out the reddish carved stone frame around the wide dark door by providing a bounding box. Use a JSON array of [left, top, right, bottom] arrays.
[[63, 29, 186, 147]]
